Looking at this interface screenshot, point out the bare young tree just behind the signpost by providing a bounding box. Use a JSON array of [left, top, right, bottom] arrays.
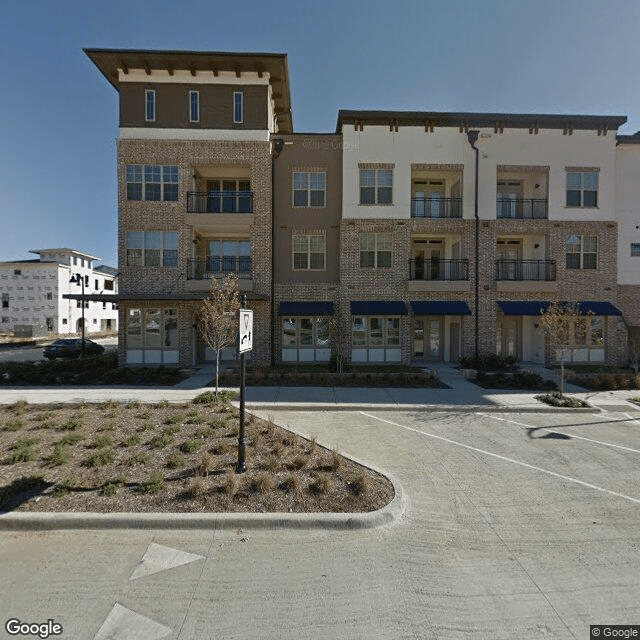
[[197, 274, 240, 395]]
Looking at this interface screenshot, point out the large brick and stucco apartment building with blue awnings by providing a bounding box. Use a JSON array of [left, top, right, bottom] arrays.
[[86, 49, 640, 366]]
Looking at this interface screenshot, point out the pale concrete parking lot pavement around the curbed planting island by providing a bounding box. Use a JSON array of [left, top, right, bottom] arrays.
[[0, 410, 640, 640]]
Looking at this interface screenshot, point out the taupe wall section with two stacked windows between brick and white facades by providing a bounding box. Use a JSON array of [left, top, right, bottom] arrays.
[[273, 134, 342, 283]]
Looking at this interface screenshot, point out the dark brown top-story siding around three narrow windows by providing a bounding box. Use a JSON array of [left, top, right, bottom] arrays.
[[120, 83, 268, 129]]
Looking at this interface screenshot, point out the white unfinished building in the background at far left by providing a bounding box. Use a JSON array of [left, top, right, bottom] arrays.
[[0, 248, 118, 336]]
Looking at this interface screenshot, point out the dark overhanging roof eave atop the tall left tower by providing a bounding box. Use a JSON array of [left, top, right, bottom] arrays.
[[83, 49, 293, 133]]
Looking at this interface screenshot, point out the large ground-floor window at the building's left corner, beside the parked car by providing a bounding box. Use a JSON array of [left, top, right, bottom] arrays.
[[126, 308, 178, 364]]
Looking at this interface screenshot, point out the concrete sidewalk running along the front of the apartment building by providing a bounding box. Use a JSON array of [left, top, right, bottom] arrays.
[[0, 363, 640, 412]]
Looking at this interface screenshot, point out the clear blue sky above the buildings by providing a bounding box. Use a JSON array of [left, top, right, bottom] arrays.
[[0, 0, 640, 266]]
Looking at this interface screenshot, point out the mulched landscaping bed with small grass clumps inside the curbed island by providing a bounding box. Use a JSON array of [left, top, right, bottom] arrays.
[[0, 392, 394, 513]]
